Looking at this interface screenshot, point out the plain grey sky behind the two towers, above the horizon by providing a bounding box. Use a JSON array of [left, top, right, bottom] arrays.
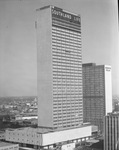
[[0, 0, 119, 97]]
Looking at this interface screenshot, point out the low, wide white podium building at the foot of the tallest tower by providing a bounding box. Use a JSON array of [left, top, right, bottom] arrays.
[[5, 124, 94, 148]]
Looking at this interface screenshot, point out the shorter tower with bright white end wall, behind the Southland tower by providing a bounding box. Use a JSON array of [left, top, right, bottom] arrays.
[[82, 63, 112, 131]]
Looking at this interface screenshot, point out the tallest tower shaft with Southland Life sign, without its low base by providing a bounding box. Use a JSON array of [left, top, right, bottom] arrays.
[[37, 6, 83, 129]]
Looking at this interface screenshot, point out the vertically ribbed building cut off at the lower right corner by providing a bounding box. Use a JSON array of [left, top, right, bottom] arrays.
[[104, 114, 119, 150]]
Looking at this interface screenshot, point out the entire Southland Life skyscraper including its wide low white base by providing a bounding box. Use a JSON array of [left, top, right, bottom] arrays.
[[2, 6, 97, 149]]
